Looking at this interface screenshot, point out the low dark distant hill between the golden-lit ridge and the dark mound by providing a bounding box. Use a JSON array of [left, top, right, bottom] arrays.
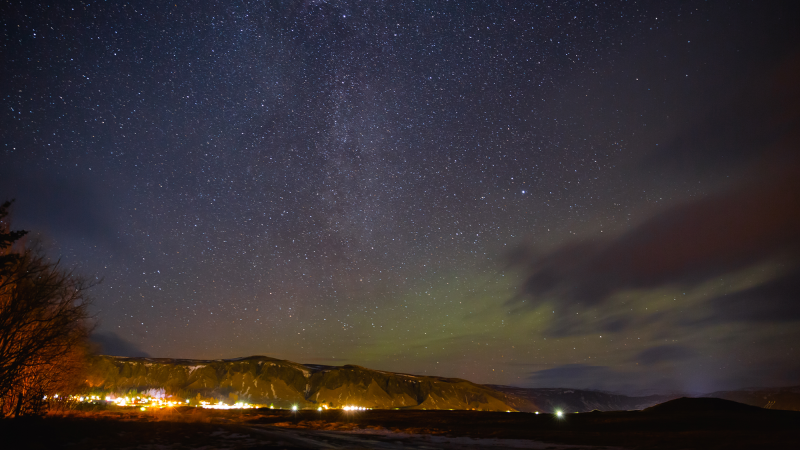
[[486, 384, 675, 413]]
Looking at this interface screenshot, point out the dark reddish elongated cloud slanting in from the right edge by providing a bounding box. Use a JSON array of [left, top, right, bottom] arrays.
[[510, 151, 800, 329]]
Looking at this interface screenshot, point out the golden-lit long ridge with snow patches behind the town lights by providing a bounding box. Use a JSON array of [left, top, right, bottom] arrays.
[[87, 356, 514, 411]]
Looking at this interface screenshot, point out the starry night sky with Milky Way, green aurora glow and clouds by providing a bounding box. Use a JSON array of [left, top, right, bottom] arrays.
[[0, 0, 800, 393]]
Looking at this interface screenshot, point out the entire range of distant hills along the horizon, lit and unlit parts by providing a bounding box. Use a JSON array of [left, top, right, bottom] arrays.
[[87, 356, 800, 413]]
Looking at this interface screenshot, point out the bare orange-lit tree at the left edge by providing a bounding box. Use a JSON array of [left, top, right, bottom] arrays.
[[0, 202, 91, 417]]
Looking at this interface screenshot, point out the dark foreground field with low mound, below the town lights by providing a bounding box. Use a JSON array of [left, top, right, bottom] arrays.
[[0, 399, 800, 450]]
